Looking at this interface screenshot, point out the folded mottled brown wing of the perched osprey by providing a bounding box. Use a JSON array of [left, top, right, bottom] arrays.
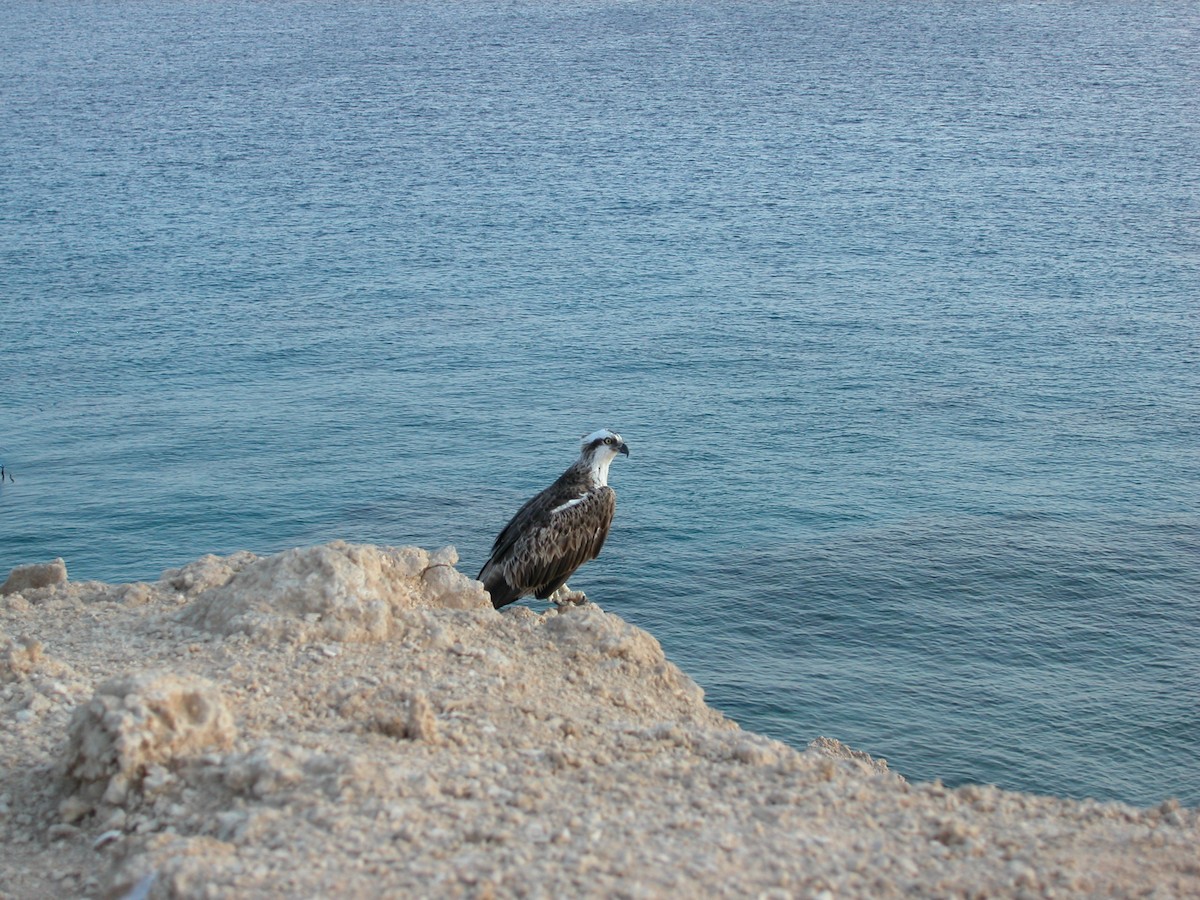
[[504, 487, 617, 599]]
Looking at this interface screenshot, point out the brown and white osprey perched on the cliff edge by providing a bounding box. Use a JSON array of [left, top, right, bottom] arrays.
[[479, 428, 629, 610]]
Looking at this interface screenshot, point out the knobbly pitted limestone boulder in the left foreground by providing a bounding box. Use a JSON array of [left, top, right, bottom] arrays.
[[61, 672, 236, 821]]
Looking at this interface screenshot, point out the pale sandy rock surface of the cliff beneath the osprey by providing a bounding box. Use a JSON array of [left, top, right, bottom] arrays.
[[0, 541, 1200, 898]]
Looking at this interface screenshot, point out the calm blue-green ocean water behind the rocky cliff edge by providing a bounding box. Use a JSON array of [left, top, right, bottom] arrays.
[[0, 0, 1200, 805]]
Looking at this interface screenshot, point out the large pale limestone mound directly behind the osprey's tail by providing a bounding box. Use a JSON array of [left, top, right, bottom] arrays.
[[181, 541, 492, 642]]
